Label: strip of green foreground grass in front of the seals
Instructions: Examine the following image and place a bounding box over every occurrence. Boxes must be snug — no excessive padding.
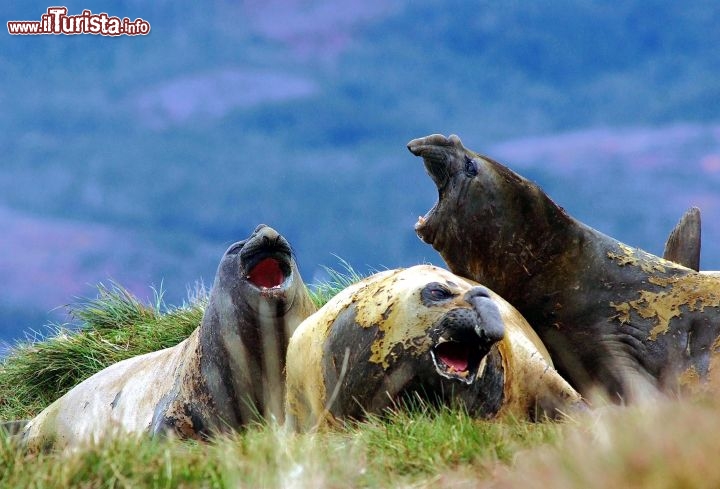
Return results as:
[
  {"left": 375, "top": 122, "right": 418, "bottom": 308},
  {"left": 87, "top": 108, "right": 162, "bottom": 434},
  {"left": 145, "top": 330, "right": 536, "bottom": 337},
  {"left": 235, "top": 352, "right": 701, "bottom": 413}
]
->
[{"left": 0, "top": 409, "right": 559, "bottom": 488}]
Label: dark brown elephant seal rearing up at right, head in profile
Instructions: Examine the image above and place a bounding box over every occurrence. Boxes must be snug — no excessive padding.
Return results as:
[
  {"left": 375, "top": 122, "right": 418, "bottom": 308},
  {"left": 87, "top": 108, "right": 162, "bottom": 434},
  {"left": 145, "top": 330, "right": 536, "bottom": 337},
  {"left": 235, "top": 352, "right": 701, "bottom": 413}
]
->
[{"left": 408, "top": 135, "right": 720, "bottom": 401}]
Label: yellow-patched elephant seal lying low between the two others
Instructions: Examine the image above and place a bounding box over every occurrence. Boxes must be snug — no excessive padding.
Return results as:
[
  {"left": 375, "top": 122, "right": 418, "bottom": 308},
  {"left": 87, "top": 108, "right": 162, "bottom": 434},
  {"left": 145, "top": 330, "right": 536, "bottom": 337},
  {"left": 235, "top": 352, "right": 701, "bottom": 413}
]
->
[{"left": 286, "top": 265, "right": 584, "bottom": 431}]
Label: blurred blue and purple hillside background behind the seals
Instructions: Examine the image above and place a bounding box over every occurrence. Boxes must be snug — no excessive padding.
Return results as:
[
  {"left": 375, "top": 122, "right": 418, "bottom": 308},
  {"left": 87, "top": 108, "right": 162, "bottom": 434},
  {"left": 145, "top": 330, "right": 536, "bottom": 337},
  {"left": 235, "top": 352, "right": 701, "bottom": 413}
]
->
[{"left": 0, "top": 0, "right": 720, "bottom": 339}]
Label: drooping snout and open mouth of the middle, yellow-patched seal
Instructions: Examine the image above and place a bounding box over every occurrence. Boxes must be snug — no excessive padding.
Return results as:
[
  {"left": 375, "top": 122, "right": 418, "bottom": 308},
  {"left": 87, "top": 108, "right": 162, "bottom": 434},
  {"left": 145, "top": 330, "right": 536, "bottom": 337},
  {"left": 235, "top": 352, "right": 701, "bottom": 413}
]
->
[{"left": 430, "top": 287, "right": 505, "bottom": 384}]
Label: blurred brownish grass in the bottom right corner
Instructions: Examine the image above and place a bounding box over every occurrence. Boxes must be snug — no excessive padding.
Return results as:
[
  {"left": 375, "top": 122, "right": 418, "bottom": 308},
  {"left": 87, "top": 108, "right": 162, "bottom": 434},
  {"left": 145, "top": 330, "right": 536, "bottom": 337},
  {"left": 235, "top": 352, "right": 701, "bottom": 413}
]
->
[{"left": 486, "top": 397, "right": 720, "bottom": 489}]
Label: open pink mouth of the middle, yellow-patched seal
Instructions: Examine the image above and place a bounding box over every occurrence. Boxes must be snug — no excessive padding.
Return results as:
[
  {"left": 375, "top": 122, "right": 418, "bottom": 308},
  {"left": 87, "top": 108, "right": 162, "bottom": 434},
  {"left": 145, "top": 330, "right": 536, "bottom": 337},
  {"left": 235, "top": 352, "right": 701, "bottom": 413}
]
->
[{"left": 430, "top": 331, "right": 489, "bottom": 384}]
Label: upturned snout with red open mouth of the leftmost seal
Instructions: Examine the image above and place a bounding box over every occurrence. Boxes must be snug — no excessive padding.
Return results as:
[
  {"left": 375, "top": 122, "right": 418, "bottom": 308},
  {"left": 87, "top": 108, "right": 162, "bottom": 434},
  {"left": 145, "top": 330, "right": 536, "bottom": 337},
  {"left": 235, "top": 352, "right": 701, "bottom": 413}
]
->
[{"left": 240, "top": 224, "right": 292, "bottom": 290}]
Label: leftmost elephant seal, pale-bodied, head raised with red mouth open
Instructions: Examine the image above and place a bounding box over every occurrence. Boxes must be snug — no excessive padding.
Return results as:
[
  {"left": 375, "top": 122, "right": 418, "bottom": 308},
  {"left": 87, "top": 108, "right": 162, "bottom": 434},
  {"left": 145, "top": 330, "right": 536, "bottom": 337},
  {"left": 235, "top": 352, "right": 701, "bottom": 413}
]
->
[{"left": 23, "top": 225, "right": 316, "bottom": 449}]
